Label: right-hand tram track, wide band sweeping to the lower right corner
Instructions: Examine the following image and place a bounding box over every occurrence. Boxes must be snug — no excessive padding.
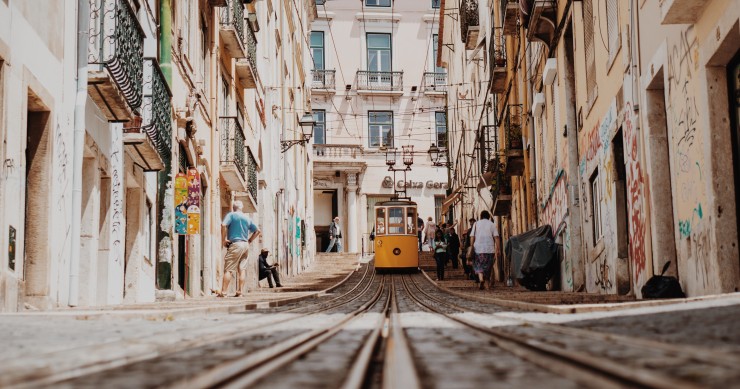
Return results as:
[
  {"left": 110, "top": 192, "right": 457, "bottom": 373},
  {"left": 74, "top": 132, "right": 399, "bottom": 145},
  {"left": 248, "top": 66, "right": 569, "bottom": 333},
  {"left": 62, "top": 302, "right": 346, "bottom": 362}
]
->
[{"left": 403, "top": 277, "right": 740, "bottom": 388}]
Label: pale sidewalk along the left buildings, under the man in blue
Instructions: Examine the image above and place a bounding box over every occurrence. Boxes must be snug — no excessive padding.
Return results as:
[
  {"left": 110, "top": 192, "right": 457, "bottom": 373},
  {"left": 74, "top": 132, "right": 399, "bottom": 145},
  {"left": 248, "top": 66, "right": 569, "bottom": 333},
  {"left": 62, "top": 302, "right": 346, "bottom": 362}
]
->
[{"left": 8, "top": 254, "right": 359, "bottom": 321}]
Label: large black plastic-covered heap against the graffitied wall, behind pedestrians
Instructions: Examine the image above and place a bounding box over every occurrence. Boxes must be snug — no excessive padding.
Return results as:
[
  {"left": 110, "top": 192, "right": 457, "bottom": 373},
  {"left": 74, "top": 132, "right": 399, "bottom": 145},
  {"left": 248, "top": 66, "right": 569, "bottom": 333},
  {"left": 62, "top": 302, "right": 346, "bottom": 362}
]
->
[{"left": 505, "top": 225, "right": 560, "bottom": 290}]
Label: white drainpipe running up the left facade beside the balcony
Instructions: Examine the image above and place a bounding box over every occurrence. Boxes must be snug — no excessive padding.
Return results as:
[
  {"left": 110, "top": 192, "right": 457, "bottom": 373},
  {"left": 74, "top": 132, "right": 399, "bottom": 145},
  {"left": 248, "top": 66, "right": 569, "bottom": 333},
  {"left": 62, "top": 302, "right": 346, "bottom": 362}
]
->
[{"left": 67, "top": 0, "right": 90, "bottom": 307}]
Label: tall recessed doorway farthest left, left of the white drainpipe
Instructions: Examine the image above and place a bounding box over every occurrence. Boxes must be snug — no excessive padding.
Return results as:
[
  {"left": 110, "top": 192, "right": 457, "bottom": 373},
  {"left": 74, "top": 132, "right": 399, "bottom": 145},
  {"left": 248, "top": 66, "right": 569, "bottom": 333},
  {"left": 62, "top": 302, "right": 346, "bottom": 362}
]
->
[{"left": 23, "top": 91, "right": 51, "bottom": 297}]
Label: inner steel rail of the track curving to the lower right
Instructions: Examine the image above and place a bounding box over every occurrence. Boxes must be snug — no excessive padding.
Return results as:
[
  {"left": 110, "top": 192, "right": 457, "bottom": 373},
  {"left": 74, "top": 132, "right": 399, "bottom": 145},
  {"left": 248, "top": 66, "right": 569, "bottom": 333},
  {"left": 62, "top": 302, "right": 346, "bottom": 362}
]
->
[{"left": 403, "top": 278, "right": 701, "bottom": 389}]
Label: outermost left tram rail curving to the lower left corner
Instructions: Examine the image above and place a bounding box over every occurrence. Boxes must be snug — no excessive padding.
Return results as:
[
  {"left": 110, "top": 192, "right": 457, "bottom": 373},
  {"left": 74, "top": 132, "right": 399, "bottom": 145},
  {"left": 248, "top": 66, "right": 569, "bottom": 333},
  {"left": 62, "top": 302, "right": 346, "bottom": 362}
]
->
[{"left": 19, "top": 264, "right": 375, "bottom": 387}]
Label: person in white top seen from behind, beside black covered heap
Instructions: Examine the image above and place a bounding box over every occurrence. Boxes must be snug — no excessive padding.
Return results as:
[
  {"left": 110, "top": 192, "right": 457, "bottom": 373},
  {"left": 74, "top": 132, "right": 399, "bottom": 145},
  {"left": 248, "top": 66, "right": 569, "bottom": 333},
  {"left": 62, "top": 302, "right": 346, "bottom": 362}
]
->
[{"left": 468, "top": 211, "right": 501, "bottom": 289}]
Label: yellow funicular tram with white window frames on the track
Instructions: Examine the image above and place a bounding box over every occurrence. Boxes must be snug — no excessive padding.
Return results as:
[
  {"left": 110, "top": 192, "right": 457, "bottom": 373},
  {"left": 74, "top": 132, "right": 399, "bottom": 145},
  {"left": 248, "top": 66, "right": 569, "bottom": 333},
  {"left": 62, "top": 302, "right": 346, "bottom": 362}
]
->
[{"left": 374, "top": 198, "right": 419, "bottom": 271}]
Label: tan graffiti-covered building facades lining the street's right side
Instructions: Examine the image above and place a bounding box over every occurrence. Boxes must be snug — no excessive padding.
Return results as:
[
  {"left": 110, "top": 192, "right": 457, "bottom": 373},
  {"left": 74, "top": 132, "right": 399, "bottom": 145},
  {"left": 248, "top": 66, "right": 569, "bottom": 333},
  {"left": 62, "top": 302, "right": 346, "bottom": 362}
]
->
[{"left": 440, "top": 0, "right": 740, "bottom": 297}]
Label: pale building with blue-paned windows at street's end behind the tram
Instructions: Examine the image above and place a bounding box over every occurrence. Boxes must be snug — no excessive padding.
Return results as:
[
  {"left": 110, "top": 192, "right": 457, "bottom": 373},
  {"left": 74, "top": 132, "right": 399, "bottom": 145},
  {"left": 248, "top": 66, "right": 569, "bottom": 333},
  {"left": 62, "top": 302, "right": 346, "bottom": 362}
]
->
[{"left": 306, "top": 0, "right": 448, "bottom": 252}]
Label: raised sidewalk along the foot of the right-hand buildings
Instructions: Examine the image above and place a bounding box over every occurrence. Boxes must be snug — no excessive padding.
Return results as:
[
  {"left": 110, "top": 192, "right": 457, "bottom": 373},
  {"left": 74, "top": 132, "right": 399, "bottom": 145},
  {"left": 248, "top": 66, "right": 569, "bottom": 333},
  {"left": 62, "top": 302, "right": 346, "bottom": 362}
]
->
[{"left": 419, "top": 253, "right": 740, "bottom": 314}]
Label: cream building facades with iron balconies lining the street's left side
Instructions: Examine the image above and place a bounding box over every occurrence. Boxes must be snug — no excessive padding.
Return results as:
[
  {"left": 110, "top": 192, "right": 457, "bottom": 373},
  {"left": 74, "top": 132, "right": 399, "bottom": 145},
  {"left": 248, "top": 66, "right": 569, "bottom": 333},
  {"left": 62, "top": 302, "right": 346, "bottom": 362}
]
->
[{"left": 0, "top": 0, "right": 315, "bottom": 311}]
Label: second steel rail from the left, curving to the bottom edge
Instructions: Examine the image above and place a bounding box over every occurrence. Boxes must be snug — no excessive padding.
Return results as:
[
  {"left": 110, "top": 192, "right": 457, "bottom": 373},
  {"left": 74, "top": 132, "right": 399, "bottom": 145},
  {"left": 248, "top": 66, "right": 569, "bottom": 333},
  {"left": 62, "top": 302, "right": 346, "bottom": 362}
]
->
[{"left": 185, "top": 278, "right": 385, "bottom": 388}]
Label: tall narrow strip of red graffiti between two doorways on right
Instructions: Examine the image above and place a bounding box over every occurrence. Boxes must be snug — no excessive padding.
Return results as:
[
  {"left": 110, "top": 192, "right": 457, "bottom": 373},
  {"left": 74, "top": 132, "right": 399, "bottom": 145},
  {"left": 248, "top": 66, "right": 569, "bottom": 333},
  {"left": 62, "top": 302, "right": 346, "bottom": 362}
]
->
[{"left": 622, "top": 102, "right": 647, "bottom": 285}]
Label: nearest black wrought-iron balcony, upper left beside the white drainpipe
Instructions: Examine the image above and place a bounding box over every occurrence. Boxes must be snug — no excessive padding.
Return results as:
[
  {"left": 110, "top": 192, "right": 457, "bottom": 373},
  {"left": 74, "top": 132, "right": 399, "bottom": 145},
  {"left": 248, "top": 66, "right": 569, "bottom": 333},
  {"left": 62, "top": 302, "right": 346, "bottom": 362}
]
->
[{"left": 87, "top": 0, "right": 144, "bottom": 122}]
